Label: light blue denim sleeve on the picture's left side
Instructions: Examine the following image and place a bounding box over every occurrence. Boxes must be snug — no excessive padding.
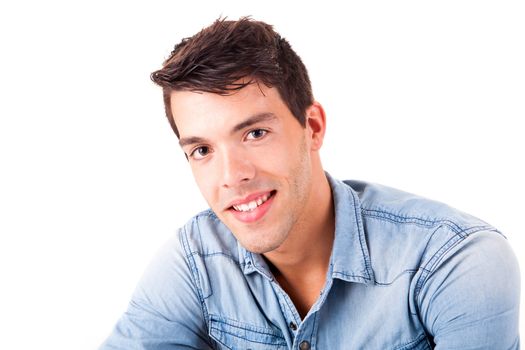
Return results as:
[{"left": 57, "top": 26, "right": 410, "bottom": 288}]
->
[{"left": 99, "top": 231, "right": 212, "bottom": 350}]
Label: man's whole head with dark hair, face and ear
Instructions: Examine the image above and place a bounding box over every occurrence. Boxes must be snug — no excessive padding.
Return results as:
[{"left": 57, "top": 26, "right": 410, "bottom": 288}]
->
[{"left": 149, "top": 19, "right": 329, "bottom": 253}]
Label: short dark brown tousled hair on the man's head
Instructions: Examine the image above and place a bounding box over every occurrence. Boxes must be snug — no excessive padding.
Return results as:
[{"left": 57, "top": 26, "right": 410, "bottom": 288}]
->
[{"left": 151, "top": 17, "right": 313, "bottom": 137}]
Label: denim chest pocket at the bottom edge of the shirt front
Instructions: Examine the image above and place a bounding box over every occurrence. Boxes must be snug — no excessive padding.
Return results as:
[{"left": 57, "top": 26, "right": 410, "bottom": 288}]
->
[{"left": 209, "top": 315, "right": 287, "bottom": 350}]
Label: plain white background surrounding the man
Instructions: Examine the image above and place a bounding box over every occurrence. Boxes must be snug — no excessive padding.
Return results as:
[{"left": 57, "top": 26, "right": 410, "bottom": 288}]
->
[{"left": 0, "top": 0, "right": 525, "bottom": 349}]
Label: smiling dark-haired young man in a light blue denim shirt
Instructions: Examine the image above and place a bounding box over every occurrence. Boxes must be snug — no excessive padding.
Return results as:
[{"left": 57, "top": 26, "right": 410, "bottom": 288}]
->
[{"left": 102, "top": 18, "right": 520, "bottom": 350}]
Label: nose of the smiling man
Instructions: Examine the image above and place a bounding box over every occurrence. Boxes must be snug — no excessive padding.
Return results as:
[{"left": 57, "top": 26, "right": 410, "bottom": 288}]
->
[{"left": 222, "top": 150, "right": 255, "bottom": 188}]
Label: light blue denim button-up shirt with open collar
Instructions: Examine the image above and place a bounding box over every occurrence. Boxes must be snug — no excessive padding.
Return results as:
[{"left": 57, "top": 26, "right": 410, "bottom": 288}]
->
[{"left": 101, "top": 175, "right": 520, "bottom": 350}]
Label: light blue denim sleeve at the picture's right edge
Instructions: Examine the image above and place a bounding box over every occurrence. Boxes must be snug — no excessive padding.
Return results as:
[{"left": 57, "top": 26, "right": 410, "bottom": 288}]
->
[{"left": 418, "top": 232, "right": 520, "bottom": 350}]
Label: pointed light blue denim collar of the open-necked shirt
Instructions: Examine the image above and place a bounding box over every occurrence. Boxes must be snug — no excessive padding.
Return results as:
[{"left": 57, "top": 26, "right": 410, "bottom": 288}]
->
[{"left": 238, "top": 173, "right": 374, "bottom": 283}]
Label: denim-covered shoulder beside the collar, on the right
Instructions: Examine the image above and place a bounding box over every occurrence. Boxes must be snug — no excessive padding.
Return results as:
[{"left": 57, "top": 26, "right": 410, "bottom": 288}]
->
[{"left": 344, "top": 181, "right": 505, "bottom": 284}]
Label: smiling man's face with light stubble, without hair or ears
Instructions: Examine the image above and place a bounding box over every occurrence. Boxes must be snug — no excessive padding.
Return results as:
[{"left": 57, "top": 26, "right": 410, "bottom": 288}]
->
[{"left": 171, "top": 84, "right": 312, "bottom": 253}]
